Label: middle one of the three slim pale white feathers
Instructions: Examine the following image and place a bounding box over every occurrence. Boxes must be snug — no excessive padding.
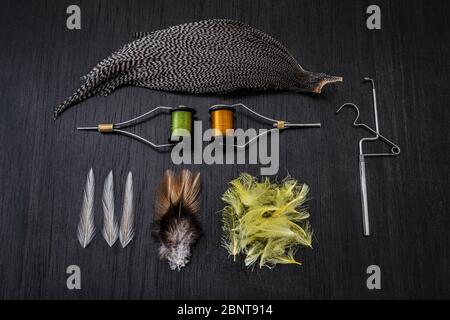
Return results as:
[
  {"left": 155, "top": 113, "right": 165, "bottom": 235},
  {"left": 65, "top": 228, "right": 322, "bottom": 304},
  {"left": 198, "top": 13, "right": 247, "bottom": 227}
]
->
[{"left": 102, "top": 171, "right": 119, "bottom": 247}]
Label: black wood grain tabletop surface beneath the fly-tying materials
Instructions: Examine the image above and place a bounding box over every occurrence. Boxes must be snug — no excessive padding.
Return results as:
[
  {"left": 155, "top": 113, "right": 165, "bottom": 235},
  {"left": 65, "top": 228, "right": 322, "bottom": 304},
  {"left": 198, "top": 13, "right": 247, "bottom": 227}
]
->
[{"left": 0, "top": 0, "right": 450, "bottom": 299}]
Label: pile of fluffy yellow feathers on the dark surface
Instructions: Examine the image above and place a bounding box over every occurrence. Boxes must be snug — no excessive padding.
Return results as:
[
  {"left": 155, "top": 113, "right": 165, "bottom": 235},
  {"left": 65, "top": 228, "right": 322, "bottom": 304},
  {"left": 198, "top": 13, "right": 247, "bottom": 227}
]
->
[{"left": 222, "top": 173, "right": 312, "bottom": 268}]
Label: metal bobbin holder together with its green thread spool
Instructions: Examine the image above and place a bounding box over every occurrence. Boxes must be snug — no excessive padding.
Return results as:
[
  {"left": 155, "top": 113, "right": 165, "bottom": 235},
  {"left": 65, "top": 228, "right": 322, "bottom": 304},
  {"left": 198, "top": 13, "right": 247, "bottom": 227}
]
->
[{"left": 77, "top": 105, "right": 195, "bottom": 149}]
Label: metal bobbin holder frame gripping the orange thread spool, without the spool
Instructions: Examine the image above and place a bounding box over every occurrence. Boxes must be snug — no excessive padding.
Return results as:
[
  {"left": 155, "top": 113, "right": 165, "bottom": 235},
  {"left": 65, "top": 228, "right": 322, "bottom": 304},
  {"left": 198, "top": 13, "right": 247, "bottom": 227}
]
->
[{"left": 209, "top": 103, "right": 322, "bottom": 148}]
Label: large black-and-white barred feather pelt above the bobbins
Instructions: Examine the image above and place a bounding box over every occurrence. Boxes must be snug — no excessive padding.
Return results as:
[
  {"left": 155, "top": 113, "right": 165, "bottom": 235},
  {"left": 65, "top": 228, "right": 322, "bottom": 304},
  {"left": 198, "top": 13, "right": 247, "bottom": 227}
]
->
[{"left": 53, "top": 19, "right": 342, "bottom": 119}]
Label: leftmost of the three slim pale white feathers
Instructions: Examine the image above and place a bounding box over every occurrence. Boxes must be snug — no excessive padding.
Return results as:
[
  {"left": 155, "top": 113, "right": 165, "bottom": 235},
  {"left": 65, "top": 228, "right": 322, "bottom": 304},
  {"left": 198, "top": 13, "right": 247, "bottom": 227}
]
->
[{"left": 77, "top": 168, "right": 95, "bottom": 248}]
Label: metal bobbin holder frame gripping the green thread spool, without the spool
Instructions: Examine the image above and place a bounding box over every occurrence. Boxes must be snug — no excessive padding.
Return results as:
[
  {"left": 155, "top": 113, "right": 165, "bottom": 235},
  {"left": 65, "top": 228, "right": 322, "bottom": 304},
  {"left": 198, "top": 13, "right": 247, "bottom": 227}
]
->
[{"left": 77, "top": 106, "right": 177, "bottom": 149}]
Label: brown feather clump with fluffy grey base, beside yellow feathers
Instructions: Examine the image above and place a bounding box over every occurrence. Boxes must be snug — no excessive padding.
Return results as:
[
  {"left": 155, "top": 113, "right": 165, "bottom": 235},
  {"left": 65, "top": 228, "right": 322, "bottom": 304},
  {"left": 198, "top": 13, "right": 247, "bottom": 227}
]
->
[{"left": 154, "top": 169, "right": 201, "bottom": 271}]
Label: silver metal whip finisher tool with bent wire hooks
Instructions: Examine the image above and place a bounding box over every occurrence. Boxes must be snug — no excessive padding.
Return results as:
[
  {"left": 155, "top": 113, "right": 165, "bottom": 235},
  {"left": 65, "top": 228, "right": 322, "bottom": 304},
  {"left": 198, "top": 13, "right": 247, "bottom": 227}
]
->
[{"left": 336, "top": 77, "right": 400, "bottom": 236}]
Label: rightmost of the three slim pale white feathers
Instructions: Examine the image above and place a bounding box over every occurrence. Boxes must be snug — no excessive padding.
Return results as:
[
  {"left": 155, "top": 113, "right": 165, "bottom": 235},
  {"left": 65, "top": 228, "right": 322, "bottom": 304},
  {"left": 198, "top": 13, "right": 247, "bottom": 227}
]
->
[{"left": 119, "top": 172, "right": 134, "bottom": 248}]
